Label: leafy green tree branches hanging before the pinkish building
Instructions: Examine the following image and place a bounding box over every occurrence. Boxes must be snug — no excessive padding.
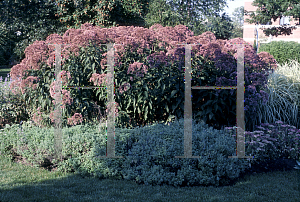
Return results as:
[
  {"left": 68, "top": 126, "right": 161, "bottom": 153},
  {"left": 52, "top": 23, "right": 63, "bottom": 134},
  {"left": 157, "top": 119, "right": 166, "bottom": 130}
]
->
[{"left": 245, "top": 0, "right": 300, "bottom": 37}]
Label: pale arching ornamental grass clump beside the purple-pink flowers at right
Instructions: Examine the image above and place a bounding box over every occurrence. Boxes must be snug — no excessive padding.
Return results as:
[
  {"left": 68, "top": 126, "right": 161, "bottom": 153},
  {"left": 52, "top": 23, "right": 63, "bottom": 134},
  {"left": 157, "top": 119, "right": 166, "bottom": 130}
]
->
[{"left": 258, "top": 60, "right": 300, "bottom": 129}]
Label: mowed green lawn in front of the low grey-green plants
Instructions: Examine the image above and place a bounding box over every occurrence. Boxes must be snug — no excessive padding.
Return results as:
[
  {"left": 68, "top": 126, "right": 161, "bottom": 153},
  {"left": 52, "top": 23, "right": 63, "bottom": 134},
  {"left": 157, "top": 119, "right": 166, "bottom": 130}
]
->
[{"left": 0, "top": 153, "right": 300, "bottom": 202}]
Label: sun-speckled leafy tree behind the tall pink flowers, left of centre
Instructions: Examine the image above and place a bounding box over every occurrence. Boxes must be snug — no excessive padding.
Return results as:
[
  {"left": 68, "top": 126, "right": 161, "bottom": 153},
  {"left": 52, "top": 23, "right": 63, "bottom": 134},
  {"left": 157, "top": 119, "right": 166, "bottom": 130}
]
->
[{"left": 48, "top": 0, "right": 154, "bottom": 29}]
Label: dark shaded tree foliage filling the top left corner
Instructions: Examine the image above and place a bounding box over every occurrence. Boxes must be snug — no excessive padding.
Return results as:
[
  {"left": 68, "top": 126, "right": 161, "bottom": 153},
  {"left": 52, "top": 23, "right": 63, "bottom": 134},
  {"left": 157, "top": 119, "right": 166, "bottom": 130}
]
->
[{"left": 0, "top": 0, "right": 71, "bottom": 64}]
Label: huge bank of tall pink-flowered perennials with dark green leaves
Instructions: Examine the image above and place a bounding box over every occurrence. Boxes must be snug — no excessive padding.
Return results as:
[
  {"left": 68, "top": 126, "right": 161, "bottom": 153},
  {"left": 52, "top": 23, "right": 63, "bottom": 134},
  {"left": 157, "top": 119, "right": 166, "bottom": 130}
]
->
[{"left": 4, "top": 23, "right": 276, "bottom": 133}]
